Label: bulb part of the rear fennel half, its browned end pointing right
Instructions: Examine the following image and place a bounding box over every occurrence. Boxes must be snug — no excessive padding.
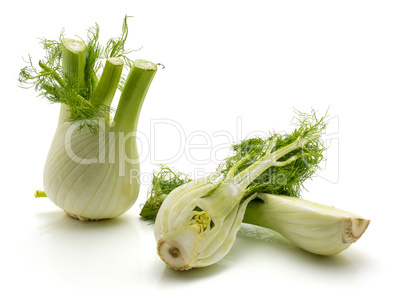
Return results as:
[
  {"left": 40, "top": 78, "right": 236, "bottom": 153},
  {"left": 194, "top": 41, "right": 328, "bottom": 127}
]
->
[{"left": 243, "top": 194, "right": 370, "bottom": 255}]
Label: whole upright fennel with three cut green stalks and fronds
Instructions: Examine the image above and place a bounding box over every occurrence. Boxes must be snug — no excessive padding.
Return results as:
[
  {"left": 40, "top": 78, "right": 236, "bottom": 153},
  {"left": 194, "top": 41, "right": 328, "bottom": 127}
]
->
[{"left": 19, "top": 17, "right": 157, "bottom": 220}]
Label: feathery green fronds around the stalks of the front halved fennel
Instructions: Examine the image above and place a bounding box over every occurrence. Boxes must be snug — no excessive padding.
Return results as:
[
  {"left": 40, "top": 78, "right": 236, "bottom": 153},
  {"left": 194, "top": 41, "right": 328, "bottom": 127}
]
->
[{"left": 226, "top": 111, "right": 327, "bottom": 198}]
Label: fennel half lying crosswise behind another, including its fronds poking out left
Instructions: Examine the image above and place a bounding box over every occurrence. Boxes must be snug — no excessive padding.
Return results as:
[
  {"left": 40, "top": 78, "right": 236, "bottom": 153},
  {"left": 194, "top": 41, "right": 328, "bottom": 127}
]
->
[{"left": 140, "top": 166, "right": 370, "bottom": 255}]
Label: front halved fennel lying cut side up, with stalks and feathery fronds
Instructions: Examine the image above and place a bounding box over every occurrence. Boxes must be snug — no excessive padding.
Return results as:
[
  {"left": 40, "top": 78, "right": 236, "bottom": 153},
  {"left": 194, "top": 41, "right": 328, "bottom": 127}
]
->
[{"left": 154, "top": 114, "right": 336, "bottom": 270}]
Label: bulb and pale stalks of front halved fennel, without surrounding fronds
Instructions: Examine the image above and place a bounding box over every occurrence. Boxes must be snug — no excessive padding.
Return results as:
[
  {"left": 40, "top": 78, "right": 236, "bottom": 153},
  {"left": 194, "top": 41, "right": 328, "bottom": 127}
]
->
[{"left": 154, "top": 122, "right": 322, "bottom": 270}]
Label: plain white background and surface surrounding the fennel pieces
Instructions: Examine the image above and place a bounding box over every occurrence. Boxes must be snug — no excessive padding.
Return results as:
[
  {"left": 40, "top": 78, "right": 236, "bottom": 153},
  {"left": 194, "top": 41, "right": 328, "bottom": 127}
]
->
[{"left": 0, "top": 0, "right": 402, "bottom": 299}]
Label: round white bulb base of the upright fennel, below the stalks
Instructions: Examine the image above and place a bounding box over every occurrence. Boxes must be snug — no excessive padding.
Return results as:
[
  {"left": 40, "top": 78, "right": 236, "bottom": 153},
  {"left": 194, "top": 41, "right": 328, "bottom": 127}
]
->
[{"left": 43, "top": 117, "right": 140, "bottom": 220}]
